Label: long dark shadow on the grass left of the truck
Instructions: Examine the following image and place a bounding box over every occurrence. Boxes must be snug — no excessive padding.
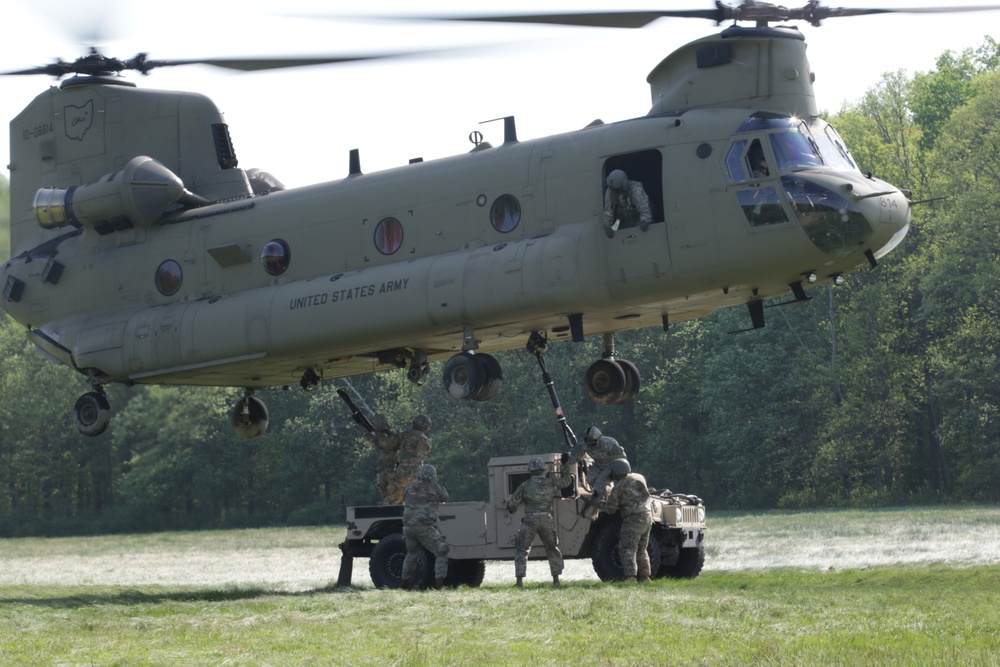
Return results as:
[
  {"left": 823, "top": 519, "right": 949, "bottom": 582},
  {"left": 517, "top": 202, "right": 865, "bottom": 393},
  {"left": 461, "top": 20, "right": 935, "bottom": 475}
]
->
[{"left": 0, "top": 585, "right": 359, "bottom": 609}]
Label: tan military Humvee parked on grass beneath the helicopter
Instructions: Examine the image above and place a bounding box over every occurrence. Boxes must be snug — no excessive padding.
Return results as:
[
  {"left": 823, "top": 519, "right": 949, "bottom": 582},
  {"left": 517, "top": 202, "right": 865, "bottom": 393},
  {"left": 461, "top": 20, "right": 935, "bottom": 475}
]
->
[{"left": 337, "top": 454, "right": 705, "bottom": 588}]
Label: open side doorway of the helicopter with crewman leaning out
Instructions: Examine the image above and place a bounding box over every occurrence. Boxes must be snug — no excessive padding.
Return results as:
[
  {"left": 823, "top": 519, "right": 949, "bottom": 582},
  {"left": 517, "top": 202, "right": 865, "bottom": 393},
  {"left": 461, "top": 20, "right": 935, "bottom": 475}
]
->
[{"left": 602, "top": 149, "right": 666, "bottom": 236}]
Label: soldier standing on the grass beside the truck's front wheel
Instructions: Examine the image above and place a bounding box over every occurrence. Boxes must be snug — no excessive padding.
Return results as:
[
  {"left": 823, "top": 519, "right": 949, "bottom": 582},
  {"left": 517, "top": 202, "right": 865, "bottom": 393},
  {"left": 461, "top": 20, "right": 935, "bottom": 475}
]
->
[{"left": 600, "top": 459, "right": 653, "bottom": 582}]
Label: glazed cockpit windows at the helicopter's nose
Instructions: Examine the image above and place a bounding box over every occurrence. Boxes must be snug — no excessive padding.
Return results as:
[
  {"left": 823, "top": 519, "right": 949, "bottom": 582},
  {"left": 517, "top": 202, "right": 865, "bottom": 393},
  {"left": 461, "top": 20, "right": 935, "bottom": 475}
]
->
[{"left": 726, "top": 112, "right": 873, "bottom": 255}]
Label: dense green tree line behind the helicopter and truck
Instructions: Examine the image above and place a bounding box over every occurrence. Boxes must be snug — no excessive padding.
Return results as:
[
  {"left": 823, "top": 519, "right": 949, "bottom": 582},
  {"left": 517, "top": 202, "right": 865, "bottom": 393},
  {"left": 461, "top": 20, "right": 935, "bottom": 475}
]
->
[{"left": 0, "top": 39, "right": 1000, "bottom": 536}]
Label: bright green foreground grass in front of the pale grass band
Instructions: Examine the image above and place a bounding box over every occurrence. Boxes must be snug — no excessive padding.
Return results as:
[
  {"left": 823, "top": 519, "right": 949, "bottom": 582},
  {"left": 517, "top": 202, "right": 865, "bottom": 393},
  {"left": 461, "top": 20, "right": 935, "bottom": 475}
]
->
[{"left": 0, "top": 566, "right": 1000, "bottom": 665}]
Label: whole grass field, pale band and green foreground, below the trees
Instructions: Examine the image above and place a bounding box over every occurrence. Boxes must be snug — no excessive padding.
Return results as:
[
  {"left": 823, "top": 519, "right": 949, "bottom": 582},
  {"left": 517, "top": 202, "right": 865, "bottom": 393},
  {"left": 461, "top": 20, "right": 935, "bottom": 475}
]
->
[{"left": 0, "top": 507, "right": 1000, "bottom": 667}]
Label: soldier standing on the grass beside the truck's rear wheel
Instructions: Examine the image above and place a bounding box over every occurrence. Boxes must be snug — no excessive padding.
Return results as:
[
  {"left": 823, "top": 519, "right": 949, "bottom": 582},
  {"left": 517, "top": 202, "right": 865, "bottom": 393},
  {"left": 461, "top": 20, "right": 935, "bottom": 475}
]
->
[{"left": 402, "top": 463, "right": 448, "bottom": 589}]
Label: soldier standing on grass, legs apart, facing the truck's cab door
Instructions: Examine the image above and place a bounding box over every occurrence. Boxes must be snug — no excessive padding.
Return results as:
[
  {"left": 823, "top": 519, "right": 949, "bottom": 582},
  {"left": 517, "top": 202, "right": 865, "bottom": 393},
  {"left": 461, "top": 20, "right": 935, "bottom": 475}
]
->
[{"left": 507, "top": 458, "right": 573, "bottom": 588}]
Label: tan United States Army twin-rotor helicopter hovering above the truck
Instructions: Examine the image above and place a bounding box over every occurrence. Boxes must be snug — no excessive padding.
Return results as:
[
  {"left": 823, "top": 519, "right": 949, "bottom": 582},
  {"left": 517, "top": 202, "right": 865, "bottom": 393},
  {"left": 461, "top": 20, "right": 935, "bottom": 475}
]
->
[{"left": 0, "top": 1, "right": 981, "bottom": 438}]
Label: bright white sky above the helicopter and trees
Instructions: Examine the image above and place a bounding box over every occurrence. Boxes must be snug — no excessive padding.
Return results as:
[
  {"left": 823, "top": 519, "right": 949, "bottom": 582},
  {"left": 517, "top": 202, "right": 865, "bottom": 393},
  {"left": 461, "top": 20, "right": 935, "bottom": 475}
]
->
[{"left": 0, "top": 0, "right": 1000, "bottom": 187}]
